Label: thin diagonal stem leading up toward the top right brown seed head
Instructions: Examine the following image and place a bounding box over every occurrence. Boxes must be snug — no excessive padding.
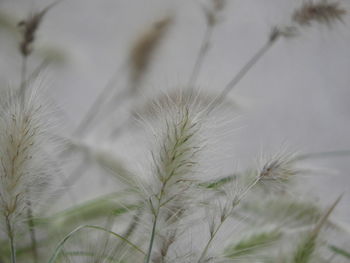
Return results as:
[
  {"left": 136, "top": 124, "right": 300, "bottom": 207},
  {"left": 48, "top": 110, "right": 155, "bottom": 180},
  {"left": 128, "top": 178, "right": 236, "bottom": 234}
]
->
[{"left": 208, "top": 36, "right": 279, "bottom": 114}]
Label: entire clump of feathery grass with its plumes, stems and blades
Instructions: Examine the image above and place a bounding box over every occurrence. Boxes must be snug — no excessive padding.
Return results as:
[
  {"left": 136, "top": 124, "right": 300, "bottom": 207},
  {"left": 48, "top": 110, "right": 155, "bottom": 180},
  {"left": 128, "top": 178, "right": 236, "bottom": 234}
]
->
[{"left": 0, "top": 0, "right": 348, "bottom": 263}]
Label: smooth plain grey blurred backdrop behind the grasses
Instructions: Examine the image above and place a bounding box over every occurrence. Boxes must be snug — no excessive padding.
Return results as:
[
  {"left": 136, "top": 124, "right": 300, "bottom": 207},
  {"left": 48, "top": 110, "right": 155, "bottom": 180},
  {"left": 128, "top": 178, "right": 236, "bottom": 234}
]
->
[{"left": 0, "top": 0, "right": 350, "bottom": 222}]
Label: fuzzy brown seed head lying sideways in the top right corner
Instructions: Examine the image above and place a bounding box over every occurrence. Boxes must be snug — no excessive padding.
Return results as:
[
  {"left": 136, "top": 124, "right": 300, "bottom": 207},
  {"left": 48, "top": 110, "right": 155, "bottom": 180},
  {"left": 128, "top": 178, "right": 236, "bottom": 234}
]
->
[{"left": 293, "top": 0, "right": 346, "bottom": 25}]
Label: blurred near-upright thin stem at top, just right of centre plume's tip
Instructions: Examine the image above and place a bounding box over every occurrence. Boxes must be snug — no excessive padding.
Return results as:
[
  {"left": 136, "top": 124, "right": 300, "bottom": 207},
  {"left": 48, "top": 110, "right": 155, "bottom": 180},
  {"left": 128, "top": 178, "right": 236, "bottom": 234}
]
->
[{"left": 188, "top": 24, "right": 214, "bottom": 89}]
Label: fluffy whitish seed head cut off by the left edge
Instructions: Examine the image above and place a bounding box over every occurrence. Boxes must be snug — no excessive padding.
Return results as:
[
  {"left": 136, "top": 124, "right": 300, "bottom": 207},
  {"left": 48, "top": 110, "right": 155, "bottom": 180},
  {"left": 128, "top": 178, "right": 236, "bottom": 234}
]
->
[{"left": 0, "top": 86, "right": 56, "bottom": 227}]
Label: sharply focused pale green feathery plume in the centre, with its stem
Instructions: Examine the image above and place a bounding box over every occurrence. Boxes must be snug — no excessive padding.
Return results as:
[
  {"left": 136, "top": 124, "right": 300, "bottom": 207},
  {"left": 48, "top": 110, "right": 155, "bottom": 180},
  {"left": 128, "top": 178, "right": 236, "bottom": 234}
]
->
[{"left": 141, "top": 92, "right": 201, "bottom": 263}]
